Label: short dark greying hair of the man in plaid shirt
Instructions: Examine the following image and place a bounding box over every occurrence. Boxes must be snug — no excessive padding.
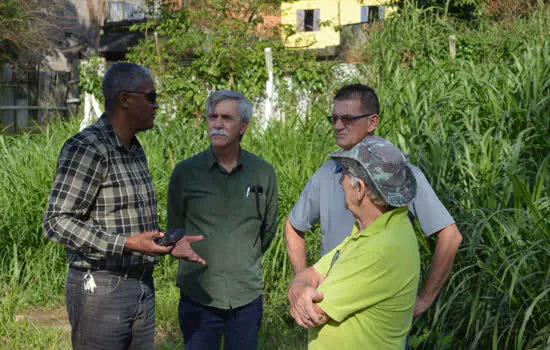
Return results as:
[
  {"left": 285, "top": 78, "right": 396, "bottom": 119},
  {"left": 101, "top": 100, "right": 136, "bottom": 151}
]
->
[{"left": 101, "top": 62, "right": 152, "bottom": 110}]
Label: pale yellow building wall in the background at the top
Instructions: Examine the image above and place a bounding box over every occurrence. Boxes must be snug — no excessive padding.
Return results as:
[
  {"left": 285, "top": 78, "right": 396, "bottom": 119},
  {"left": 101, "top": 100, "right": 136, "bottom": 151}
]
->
[{"left": 281, "top": 0, "right": 389, "bottom": 49}]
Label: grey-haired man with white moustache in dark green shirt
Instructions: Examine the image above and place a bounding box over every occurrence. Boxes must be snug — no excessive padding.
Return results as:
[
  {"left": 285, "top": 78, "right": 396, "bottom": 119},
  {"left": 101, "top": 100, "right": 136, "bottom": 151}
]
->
[{"left": 168, "top": 90, "right": 277, "bottom": 350}]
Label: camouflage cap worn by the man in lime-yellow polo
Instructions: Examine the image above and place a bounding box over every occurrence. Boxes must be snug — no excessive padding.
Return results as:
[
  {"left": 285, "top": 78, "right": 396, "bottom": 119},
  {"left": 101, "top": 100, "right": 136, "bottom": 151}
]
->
[{"left": 330, "top": 136, "right": 416, "bottom": 207}]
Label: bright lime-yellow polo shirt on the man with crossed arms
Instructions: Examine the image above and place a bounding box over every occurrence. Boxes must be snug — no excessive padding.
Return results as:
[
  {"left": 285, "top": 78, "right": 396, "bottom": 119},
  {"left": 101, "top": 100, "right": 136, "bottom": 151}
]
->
[{"left": 308, "top": 207, "right": 420, "bottom": 350}]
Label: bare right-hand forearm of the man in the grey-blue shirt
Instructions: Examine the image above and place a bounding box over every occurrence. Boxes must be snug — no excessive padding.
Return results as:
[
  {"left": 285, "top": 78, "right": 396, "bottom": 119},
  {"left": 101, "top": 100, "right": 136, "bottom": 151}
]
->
[{"left": 418, "top": 224, "right": 462, "bottom": 305}]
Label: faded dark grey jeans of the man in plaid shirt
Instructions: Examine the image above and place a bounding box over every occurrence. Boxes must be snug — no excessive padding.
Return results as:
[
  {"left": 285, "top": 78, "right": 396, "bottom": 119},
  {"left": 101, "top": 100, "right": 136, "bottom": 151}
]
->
[{"left": 65, "top": 266, "right": 155, "bottom": 350}]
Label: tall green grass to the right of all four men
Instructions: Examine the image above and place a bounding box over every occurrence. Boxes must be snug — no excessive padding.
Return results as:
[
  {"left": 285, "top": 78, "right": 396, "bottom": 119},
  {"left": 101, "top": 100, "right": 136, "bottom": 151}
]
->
[{"left": 366, "top": 8, "right": 550, "bottom": 349}]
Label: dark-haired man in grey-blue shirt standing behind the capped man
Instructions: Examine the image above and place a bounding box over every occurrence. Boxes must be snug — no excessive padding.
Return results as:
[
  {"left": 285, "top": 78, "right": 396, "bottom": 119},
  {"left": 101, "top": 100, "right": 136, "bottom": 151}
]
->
[{"left": 285, "top": 84, "right": 462, "bottom": 316}]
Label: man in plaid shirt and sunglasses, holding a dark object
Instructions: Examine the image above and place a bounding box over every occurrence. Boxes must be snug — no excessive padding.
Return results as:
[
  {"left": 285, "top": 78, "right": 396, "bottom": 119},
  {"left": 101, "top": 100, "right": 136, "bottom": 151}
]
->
[{"left": 43, "top": 63, "right": 187, "bottom": 349}]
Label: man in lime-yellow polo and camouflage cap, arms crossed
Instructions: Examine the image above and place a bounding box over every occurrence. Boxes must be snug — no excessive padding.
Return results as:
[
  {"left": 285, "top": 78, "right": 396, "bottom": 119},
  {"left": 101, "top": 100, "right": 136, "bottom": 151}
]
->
[{"left": 288, "top": 136, "right": 420, "bottom": 350}]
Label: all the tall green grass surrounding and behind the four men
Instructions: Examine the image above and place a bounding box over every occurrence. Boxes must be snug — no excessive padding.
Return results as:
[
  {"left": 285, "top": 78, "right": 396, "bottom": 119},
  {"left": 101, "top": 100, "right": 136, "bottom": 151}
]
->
[{"left": 0, "top": 4, "right": 550, "bottom": 349}]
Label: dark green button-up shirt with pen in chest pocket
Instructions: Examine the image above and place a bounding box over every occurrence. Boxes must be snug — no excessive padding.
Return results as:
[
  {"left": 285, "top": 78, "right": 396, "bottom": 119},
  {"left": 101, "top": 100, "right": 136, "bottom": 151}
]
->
[{"left": 168, "top": 148, "right": 277, "bottom": 309}]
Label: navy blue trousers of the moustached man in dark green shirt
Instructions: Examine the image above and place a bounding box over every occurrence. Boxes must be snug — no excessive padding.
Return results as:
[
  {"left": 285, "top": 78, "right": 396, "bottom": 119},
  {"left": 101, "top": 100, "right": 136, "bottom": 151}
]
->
[{"left": 179, "top": 295, "right": 262, "bottom": 350}]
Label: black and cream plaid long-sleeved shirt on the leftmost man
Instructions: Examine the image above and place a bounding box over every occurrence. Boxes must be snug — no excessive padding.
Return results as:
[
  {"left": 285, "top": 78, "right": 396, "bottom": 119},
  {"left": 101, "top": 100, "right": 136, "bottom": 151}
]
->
[{"left": 43, "top": 115, "right": 158, "bottom": 269}]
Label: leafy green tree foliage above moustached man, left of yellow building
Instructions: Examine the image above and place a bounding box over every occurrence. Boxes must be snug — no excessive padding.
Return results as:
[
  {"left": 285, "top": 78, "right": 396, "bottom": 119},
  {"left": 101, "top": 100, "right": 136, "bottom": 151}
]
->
[{"left": 128, "top": 0, "right": 332, "bottom": 118}]
